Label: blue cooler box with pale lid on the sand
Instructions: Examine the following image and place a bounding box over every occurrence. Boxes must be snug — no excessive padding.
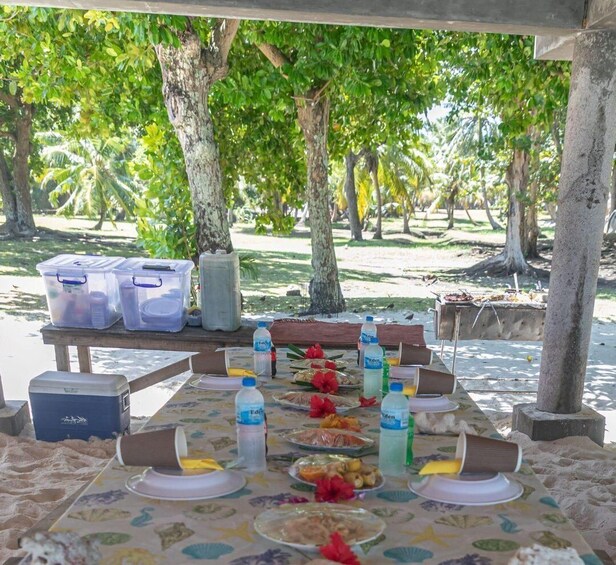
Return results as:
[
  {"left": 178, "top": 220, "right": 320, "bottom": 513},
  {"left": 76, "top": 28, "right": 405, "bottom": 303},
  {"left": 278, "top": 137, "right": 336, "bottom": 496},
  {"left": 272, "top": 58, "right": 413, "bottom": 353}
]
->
[{"left": 28, "top": 371, "right": 130, "bottom": 441}]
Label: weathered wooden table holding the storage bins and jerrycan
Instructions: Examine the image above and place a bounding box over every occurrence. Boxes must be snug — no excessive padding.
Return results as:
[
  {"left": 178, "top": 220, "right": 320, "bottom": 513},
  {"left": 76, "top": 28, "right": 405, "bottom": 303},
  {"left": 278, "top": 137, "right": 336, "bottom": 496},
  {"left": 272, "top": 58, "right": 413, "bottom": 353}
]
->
[{"left": 41, "top": 320, "right": 255, "bottom": 392}]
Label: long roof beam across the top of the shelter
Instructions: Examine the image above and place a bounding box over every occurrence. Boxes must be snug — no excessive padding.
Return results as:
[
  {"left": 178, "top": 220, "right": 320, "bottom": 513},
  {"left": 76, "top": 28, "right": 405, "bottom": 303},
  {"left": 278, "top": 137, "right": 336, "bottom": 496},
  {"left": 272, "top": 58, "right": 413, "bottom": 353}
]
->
[{"left": 2, "top": 0, "right": 584, "bottom": 35}]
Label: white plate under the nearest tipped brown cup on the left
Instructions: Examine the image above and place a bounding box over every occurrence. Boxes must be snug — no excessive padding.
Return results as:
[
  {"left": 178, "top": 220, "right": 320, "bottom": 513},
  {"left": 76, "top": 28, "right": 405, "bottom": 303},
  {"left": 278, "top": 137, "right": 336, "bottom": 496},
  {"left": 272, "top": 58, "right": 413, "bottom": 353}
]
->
[{"left": 126, "top": 467, "right": 246, "bottom": 500}]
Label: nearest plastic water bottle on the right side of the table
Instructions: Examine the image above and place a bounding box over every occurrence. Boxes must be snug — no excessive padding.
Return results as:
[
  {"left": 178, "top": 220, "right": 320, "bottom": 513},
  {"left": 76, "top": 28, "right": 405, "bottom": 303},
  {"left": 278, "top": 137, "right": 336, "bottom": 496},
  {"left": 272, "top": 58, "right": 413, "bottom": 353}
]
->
[{"left": 379, "top": 383, "right": 409, "bottom": 477}]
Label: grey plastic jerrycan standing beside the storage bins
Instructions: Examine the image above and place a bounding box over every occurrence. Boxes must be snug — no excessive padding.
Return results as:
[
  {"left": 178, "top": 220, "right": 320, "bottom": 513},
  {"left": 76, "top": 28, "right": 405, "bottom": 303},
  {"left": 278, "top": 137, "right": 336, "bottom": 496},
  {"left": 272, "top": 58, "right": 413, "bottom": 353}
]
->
[{"left": 199, "top": 251, "right": 242, "bottom": 332}]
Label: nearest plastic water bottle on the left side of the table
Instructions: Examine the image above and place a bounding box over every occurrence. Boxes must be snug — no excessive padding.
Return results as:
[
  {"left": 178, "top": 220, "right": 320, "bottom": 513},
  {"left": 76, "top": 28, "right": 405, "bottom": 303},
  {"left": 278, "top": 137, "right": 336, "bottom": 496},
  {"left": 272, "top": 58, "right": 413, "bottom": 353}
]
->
[{"left": 235, "top": 377, "right": 266, "bottom": 472}]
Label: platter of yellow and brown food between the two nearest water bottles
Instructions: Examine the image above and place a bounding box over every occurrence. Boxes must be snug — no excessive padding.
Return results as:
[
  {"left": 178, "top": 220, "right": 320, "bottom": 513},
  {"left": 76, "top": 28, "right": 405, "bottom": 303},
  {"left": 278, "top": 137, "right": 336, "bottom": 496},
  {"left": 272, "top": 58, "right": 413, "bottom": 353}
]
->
[{"left": 289, "top": 453, "right": 385, "bottom": 493}]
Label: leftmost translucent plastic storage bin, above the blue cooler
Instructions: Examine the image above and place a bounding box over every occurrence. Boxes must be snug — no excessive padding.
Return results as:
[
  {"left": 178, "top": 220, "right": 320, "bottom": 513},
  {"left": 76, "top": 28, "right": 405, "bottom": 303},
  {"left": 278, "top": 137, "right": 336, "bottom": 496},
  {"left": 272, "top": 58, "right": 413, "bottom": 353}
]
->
[{"left": 36, "top": 255, "right": 124, "bottom": 329}]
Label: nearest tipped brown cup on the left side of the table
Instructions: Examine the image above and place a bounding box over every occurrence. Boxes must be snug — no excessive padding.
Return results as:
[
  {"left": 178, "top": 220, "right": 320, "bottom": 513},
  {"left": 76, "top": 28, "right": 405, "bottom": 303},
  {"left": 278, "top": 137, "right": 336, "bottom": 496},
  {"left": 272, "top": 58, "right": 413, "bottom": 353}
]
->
[{"left": 116, "top": 426, "right": 188, "bottom": 469}]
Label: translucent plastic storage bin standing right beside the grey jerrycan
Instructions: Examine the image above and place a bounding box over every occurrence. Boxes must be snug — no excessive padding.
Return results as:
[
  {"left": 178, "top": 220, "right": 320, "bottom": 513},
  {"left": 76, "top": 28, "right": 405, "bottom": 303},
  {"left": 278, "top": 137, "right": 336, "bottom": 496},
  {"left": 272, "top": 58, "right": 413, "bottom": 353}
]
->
[{"left": 113, "top": 258, "right": 194, "bottom": 332}]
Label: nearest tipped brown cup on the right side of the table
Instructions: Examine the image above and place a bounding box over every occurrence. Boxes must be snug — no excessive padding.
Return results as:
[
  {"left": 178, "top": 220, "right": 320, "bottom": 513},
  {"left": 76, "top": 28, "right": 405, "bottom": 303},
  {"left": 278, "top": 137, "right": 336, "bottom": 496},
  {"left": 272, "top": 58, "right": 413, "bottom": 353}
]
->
[{"left": 456, "top": 432, "right": 522, "bottom": 473}]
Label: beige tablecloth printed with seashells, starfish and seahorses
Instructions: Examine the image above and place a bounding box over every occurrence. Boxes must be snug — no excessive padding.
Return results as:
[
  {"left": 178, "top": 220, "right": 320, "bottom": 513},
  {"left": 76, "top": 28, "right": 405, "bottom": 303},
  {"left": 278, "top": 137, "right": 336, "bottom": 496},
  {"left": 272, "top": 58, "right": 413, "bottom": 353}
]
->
[{"left": 53, "top": 350, "right": 600, "bottom": 565}]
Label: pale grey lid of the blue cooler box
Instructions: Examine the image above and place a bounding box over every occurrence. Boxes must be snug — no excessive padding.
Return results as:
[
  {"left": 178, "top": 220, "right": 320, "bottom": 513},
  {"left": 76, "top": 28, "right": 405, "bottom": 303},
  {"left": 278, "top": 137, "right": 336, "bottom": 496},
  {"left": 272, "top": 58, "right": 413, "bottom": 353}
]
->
[{"left": 28, "top": 371, "right": 129, "bottom": 396}]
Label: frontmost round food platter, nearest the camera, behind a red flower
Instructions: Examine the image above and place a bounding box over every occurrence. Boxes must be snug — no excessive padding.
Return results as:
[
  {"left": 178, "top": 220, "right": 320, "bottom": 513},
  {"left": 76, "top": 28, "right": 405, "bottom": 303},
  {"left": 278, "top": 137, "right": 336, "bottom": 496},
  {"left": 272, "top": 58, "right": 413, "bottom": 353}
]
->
[{"left": 254, "top": 502, "right": 385, "bottom": 551}]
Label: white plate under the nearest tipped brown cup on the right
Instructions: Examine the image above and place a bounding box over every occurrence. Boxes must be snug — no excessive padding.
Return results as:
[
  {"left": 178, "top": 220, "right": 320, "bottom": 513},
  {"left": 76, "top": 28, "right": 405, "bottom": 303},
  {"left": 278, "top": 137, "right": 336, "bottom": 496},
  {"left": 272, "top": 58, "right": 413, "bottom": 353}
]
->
[{"left": 409, "top": 473, "right": 524, "bottom": 506}]
